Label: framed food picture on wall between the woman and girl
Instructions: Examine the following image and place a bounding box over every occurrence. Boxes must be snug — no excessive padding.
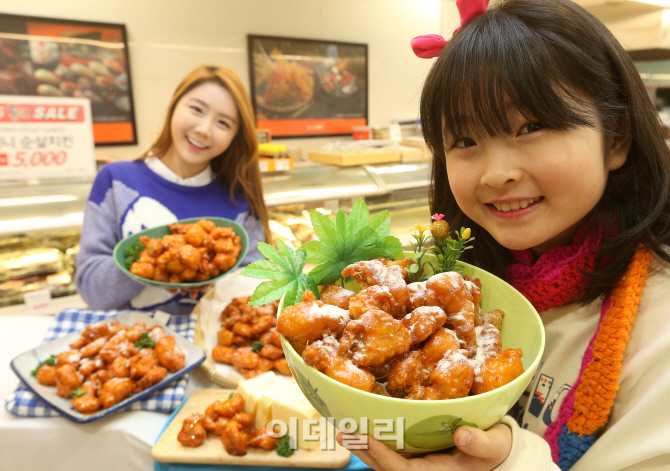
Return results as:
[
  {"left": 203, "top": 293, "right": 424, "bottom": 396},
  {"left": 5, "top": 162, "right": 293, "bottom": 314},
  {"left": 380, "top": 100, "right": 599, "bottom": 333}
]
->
[{"left": 247, "top": 35, "right": 368, "bottom": 138}]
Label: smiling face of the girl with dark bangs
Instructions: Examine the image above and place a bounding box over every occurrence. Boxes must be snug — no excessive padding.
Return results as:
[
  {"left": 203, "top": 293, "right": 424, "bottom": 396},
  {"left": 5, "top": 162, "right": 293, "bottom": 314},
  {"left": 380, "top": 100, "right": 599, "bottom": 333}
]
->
[{"left": 446, "top": 111, "right": 628, "bottom": 256}]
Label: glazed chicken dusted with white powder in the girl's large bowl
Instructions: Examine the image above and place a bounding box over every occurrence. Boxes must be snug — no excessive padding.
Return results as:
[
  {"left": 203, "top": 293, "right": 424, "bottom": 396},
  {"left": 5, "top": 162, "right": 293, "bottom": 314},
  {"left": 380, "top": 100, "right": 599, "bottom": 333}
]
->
[{"left": 277, "top": 258, "right": 524, "bottom": 400}]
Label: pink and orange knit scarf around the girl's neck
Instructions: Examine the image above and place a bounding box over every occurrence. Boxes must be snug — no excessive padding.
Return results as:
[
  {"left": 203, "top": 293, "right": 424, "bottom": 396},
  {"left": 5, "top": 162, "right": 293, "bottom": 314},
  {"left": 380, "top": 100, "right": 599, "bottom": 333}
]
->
[{"left": 507, "top": 226, "right": 651, "bottom": 471}]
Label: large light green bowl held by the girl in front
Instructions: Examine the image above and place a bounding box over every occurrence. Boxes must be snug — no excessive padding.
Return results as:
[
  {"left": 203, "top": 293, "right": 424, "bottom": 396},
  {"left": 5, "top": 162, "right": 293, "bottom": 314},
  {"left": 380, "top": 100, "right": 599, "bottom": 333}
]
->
[{"left": 278, "top": 252, "right": 544, "bottom": 453}]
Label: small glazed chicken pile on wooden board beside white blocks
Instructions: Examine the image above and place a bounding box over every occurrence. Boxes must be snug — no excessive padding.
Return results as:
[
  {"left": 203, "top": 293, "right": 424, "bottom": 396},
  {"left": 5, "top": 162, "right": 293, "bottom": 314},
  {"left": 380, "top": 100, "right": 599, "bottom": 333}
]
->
[{"left": 177, "top": 394, "right": 279, "bottom": 456}]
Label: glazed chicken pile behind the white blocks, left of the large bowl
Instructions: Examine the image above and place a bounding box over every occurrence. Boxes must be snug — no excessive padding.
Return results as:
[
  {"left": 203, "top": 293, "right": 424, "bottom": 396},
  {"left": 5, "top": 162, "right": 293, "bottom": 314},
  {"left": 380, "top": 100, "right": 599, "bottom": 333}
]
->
[{"left": 212, "top": 296, "right": 291, "bottom": 379}]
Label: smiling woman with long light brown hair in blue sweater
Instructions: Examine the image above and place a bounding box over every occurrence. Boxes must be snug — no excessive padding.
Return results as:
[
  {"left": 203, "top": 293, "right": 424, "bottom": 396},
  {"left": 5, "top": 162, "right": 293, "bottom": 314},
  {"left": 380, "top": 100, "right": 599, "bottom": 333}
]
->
[{"left": 75, "top": 66, "right": 270, "bottom": 314}]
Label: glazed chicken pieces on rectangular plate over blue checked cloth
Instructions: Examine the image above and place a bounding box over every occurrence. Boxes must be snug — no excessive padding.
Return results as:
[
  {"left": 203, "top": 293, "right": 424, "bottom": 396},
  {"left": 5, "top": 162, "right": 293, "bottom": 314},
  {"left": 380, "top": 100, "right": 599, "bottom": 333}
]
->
[{"left": 37, "top": 322, "right": 186, "bottom": 413}]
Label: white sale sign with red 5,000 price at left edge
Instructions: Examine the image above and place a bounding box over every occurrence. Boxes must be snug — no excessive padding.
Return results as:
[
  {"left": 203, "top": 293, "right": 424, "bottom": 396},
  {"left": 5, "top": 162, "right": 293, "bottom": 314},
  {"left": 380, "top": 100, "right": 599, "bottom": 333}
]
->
[{"left": 0, "top": 95, "right": 95, "bottom": 180}]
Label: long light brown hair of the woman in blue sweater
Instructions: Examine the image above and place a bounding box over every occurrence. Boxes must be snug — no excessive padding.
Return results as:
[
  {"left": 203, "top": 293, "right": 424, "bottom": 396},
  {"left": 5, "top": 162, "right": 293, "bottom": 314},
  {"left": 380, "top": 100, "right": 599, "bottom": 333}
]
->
[{"left": 140, "top": 65, "right": 271, "bottom": 242}]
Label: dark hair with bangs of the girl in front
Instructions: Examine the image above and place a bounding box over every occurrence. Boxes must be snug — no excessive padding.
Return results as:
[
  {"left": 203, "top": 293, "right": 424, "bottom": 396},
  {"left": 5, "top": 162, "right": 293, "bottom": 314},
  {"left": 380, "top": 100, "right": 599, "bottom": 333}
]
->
[{"left": 421, "top": 0, "right": 670, "bottom": 302}]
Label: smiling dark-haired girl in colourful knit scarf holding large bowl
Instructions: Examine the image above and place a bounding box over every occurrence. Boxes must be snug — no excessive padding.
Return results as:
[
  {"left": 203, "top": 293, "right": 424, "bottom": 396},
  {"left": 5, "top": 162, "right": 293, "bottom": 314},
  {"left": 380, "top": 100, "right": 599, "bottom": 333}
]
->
[{"left": 340, "top": 0, "right": 670, "bottom": 471}]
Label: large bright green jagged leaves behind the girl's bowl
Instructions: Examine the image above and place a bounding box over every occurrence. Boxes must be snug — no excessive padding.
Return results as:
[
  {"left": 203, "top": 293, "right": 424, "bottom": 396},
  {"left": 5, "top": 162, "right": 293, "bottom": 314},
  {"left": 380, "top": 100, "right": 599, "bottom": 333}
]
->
[{"left": 242, "top": 199, "right": 402, "bottom": 306}]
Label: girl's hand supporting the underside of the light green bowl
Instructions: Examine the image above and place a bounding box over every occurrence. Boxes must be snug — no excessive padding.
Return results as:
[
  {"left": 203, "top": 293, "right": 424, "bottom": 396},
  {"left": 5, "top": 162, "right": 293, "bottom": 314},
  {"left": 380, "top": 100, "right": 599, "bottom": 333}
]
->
[{"left": 337, "top": 424, "right": 512, "bottom": 471}]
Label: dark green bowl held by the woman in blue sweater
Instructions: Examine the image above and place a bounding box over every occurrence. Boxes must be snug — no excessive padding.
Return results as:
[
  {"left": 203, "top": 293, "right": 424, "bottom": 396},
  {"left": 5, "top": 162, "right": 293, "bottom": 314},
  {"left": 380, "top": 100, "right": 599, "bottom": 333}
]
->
[{"left": 114, "top": 217, "right": 249, "bottom": 289}]
